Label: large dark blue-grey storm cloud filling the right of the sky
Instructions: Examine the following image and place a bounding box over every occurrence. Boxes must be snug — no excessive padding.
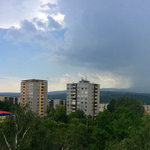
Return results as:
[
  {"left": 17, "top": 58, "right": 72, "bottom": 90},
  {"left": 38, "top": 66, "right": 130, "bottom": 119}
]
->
[{"left": 56, "top": 0, "right": 150, "bottom": 92}]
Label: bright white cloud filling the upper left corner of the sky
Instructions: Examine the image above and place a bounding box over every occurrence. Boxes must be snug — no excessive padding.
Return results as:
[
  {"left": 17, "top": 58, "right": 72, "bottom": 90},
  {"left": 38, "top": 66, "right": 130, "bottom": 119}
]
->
[{"left": 0, "top": 0, "right": 57, "bottom": 28}]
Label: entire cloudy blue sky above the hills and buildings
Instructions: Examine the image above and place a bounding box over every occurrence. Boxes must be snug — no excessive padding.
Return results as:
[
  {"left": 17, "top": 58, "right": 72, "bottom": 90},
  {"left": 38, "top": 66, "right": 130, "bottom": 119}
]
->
[{"left": 0, "top": 0, "right": 150, "bottom": 93}]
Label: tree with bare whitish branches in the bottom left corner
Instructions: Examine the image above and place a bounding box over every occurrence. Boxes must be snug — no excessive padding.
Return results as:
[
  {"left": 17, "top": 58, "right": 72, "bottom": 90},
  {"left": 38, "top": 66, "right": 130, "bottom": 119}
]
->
[{"left": 0, "top": 107, "right": 53, "bottom": 150}]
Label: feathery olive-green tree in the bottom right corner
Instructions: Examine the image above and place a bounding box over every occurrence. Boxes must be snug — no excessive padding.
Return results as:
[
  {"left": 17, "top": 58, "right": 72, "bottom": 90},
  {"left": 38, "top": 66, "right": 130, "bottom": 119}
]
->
[{"left": 106, "top": 116, "right": 150, "bottom": 150}]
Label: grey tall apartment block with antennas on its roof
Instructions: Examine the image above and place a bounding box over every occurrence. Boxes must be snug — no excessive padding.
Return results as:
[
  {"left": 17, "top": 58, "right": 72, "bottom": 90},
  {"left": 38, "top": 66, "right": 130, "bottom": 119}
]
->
[{"left": 66, "top": 79, "right": 100, "bottom": 118}]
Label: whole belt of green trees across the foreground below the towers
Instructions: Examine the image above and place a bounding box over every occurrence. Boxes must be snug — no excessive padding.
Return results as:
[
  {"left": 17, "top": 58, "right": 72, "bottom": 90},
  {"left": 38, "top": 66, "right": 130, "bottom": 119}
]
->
[{"left": 0, "top": 98, "right": 150, "bottom": 150}]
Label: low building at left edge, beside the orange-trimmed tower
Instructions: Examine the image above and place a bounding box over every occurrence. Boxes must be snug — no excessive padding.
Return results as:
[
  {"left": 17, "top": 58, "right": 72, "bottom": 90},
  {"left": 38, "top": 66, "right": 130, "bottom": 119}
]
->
[{"left": 0, "top": 96, "right": 20, "bottom": 105}]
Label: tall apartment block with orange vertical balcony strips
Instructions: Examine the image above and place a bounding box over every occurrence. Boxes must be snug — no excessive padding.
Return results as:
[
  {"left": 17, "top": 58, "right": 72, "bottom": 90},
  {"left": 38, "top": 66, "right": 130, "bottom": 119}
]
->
[{"left": 21, "top": 79, "right": 48, "bottom": 117}]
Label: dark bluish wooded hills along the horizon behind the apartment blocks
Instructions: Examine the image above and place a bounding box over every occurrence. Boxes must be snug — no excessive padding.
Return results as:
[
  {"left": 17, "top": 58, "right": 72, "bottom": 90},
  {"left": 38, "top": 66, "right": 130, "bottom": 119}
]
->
[{"left": 0, "top": 88, "right": 150, "bottom": 105}]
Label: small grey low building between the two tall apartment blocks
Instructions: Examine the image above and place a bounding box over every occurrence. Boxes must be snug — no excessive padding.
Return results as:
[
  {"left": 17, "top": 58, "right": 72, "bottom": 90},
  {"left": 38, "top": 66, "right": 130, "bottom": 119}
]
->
[{"left": 48, "top": 99, "right": 66, "bottom": 108}]
